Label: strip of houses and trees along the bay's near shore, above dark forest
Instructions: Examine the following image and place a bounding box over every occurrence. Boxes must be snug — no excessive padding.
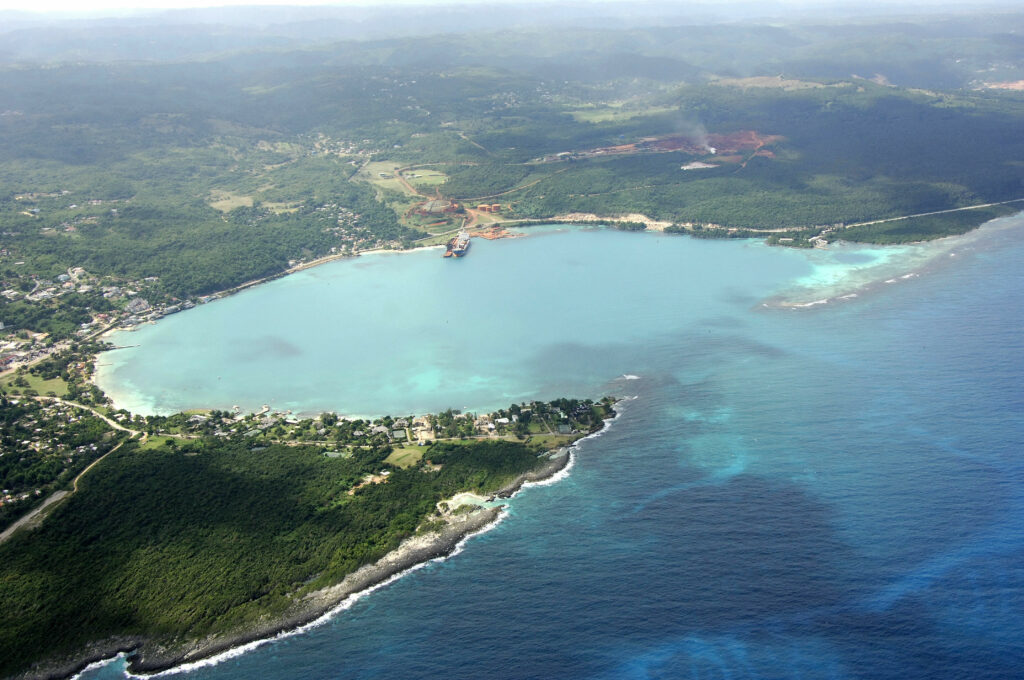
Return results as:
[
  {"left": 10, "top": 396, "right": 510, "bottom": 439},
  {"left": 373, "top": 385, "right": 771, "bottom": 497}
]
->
[{"left": 0, "top": 356, "right": 614, "bottom": 541}]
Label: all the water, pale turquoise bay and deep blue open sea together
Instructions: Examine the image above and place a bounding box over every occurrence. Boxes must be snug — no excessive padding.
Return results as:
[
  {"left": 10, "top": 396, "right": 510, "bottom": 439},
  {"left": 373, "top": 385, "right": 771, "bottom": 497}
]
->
[{"left": 85, "top": 216, "right": 1024, "bottom": 679}]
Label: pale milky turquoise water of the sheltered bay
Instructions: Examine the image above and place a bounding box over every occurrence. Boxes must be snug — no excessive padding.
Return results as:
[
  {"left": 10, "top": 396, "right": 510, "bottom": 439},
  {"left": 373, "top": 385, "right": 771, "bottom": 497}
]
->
[{"left": 98, "top": 229, "right": 946, "bottom": 415}]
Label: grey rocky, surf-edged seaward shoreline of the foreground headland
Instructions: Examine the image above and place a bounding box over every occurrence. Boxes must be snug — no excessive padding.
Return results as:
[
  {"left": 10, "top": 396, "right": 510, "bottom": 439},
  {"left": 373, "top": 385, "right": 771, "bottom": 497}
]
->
[{"left": 32, "top": 446, "right": 585, "bottom": 680}]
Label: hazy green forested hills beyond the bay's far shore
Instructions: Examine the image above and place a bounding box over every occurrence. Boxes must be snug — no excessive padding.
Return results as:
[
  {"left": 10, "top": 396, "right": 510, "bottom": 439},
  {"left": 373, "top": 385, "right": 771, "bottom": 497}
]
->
[{"left": 6, "top": 9, "right": 1024, "bottom": 330}]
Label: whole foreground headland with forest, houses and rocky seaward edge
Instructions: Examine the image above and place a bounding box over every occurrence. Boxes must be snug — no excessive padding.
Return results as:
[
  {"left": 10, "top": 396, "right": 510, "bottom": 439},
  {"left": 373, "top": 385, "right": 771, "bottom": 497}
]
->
[{"left": 0, "top": 396, "right": 614, "bottom": 678}]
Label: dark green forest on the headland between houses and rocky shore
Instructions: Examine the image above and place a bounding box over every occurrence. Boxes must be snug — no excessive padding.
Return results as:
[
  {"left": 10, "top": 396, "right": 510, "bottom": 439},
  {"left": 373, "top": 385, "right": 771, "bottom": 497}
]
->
[{"left": 0, "top": 438, "right": 577, "bottom": 676}]
